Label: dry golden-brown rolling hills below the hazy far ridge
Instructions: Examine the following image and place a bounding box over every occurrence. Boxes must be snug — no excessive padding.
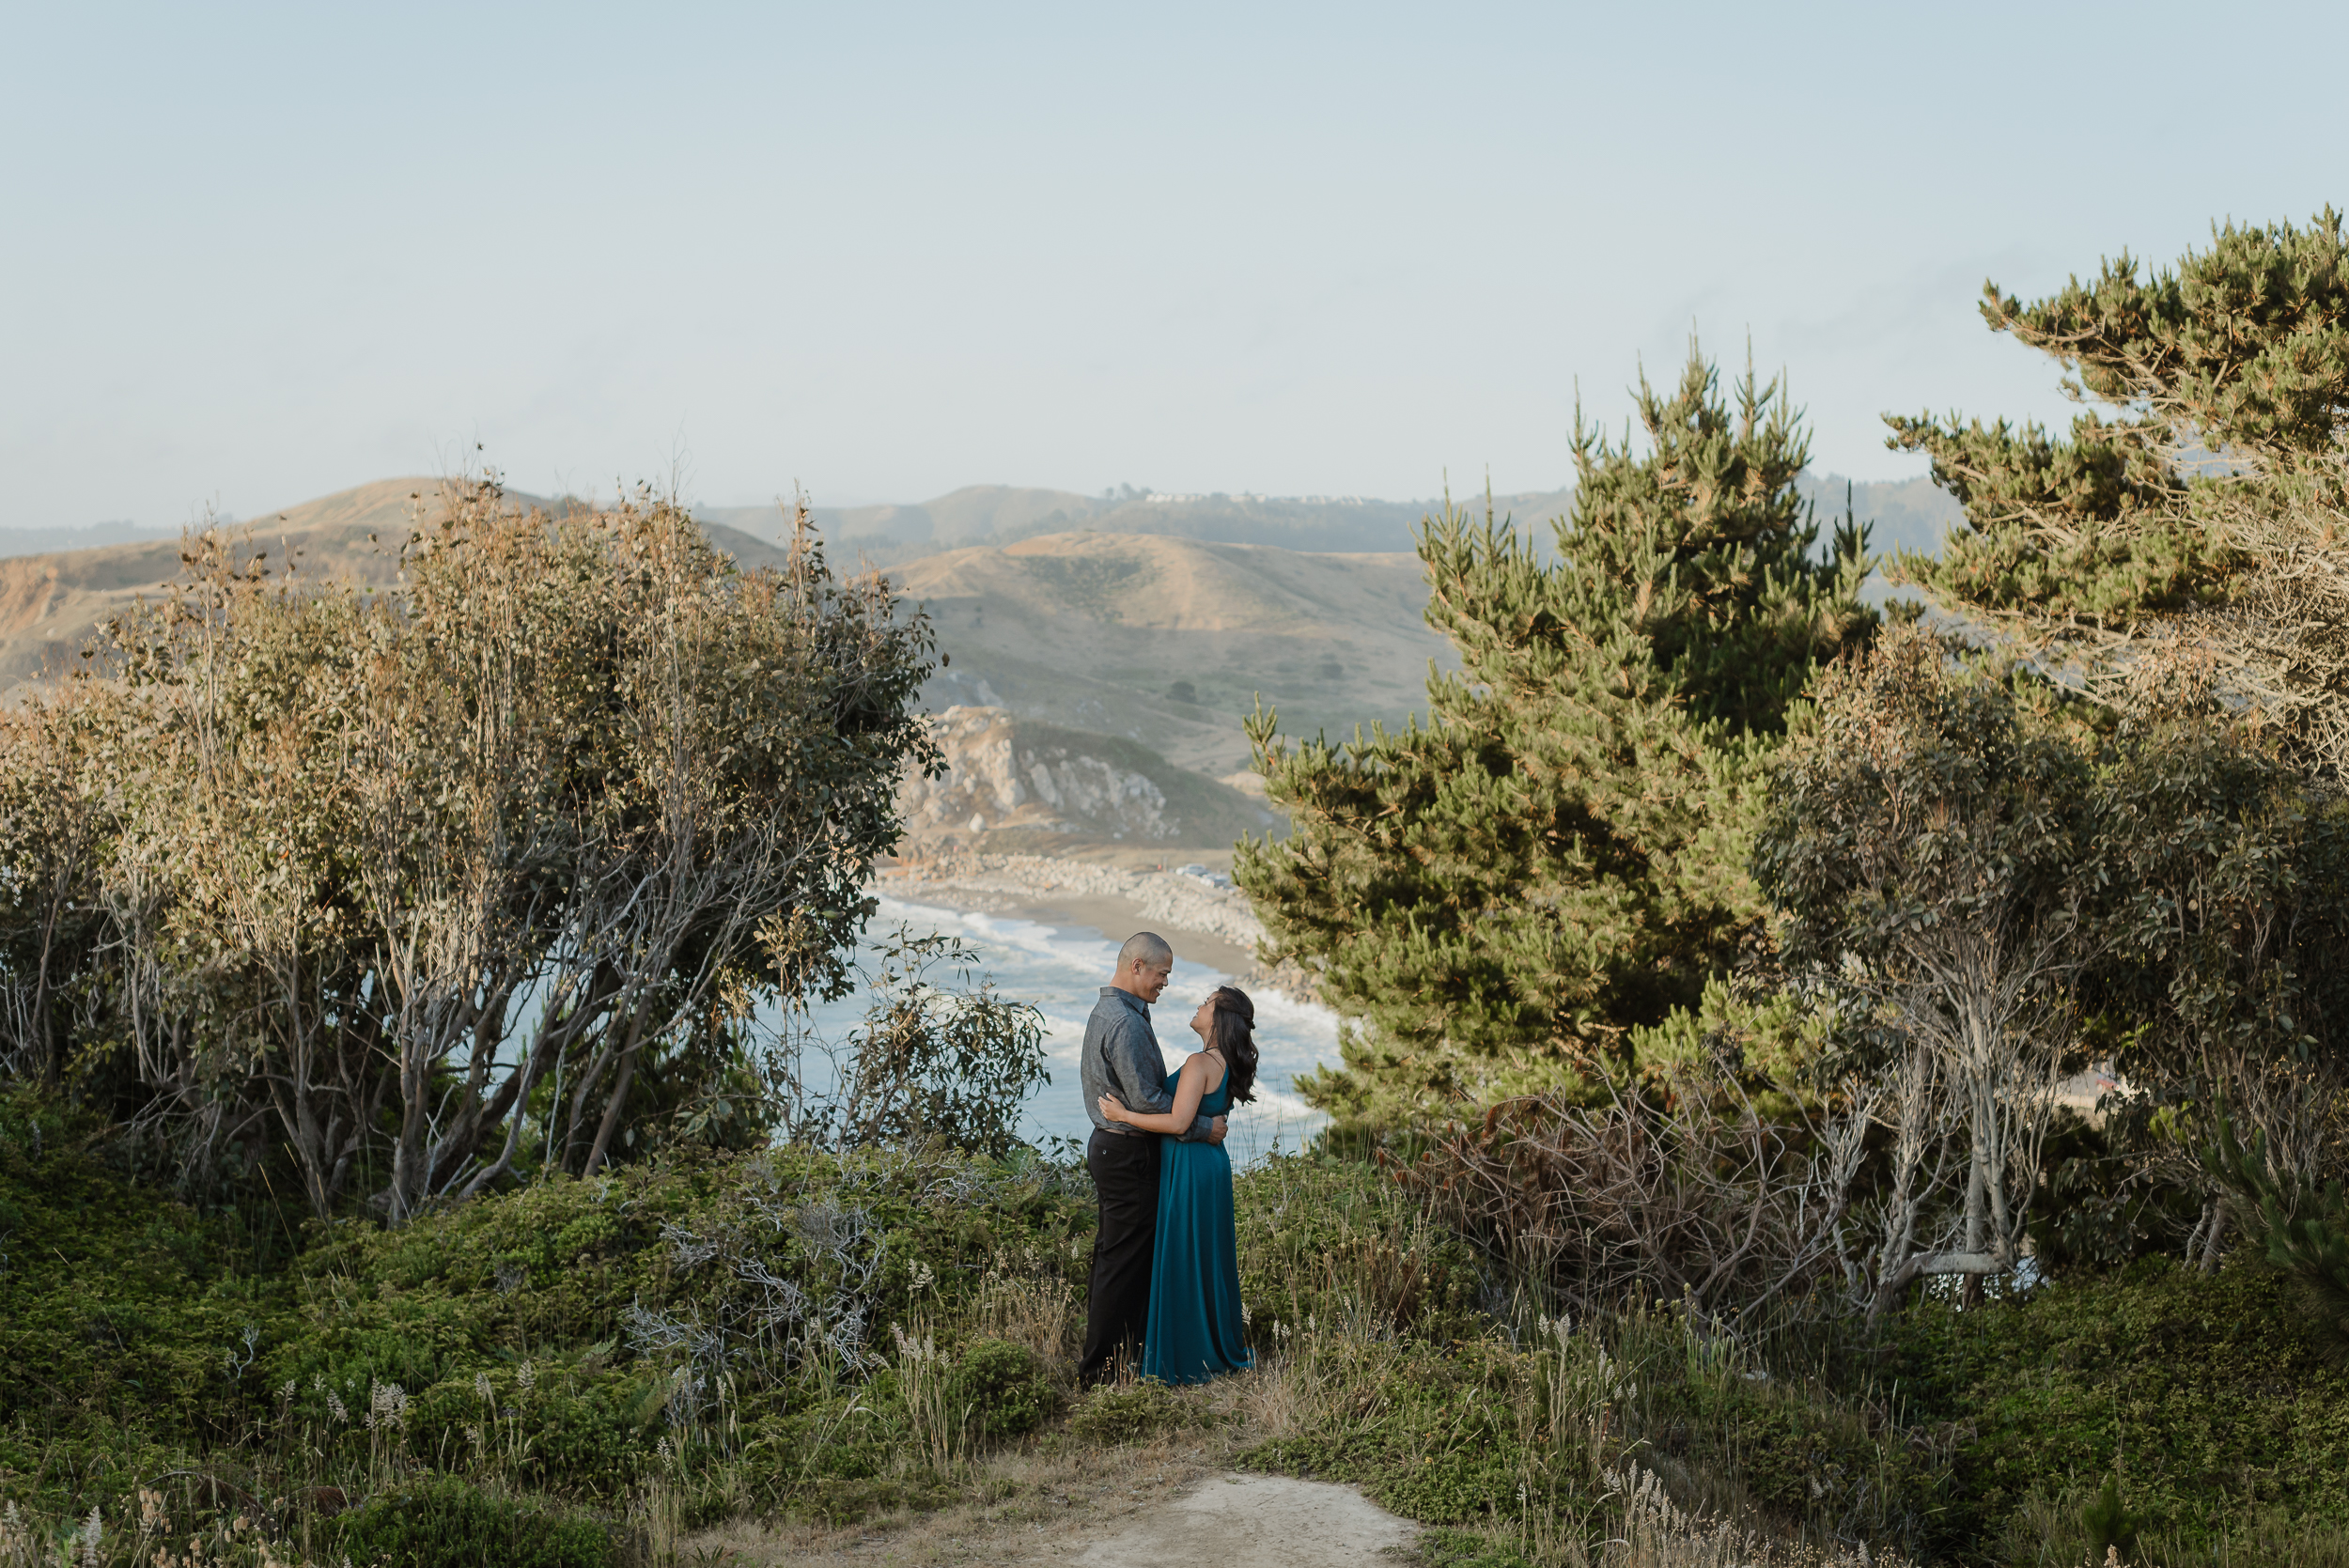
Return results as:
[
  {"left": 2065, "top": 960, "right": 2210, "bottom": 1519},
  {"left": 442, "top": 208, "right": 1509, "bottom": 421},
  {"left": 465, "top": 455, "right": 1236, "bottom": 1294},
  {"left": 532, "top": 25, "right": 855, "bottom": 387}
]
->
[{"left": 0, "top": 479, "right": 1450, "bottom": 780}]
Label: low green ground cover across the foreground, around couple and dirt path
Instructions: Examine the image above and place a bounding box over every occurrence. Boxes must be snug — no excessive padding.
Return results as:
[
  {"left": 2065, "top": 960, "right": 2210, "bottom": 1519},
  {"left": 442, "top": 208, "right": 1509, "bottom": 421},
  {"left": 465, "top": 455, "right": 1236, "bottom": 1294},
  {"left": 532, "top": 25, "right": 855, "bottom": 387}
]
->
[{"left": 0, "top": 1098, "right": 2349, "bottom": 1568}]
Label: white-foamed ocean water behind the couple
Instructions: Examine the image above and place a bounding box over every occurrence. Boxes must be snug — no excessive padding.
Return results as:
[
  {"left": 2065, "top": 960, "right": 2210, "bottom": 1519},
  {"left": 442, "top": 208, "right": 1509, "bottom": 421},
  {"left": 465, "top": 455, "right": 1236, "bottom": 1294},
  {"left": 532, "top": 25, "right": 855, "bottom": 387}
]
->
[{"left": 808, "top": 896, "right": 1337, "bottom": 1164}]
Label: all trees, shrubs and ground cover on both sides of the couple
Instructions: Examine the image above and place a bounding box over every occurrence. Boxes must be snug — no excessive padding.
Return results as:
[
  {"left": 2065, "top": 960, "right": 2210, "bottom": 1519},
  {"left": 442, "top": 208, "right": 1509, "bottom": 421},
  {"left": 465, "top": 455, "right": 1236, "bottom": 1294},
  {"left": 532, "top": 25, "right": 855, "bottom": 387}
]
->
[{"left": 0, "top": 213, "right": 2349, "bottom": 1568}]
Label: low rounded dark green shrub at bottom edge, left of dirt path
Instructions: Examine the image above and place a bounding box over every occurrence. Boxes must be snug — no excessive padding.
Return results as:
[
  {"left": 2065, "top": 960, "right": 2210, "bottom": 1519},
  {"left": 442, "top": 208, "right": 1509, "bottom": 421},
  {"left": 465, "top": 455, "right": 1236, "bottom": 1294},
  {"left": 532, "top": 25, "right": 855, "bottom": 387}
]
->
[{"left": 334, "top": 1477, "right": 618, "bottom": 1568}]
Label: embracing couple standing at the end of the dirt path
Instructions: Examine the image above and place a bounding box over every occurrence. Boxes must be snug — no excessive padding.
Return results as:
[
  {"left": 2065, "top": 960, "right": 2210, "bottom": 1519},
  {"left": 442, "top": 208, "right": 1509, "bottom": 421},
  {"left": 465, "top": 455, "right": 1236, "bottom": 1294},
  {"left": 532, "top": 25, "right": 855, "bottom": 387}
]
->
[{"left": 1076, "top": 932, "right": 1257, "bottom": 1385}]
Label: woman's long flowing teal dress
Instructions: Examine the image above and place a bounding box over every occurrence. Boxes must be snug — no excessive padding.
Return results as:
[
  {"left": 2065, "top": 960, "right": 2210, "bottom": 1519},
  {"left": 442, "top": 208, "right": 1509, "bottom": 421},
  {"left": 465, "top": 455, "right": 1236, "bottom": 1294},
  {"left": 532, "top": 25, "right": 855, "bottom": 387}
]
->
[{"left": 1142, "top": 1073, "right": 1252, "bottom": 1383}]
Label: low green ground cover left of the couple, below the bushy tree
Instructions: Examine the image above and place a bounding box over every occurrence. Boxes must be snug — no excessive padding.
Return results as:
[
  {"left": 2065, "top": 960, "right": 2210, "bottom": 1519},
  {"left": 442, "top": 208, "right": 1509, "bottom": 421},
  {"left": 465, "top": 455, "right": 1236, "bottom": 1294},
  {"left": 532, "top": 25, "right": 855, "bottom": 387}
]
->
[{"left": 0, "top": 1098, "right": 1093, "bottom": 1554}]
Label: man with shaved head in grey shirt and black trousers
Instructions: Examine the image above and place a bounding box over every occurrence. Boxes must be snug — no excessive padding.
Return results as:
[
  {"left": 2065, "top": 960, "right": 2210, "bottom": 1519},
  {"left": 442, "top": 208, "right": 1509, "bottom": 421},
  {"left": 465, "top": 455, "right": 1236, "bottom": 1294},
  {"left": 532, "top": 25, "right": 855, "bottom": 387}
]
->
[{"left": 1076, "top": 932, "right": 1224, "bottom": 1385}]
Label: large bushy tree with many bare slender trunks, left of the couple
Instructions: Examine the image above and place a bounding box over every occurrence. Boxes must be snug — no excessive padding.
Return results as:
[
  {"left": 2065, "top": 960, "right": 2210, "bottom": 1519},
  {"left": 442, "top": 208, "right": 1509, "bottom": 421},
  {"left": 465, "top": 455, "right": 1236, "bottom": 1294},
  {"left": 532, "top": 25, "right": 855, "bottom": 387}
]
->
[{"left": 0, "top": 484, "right": 935, "bottom": 1220}]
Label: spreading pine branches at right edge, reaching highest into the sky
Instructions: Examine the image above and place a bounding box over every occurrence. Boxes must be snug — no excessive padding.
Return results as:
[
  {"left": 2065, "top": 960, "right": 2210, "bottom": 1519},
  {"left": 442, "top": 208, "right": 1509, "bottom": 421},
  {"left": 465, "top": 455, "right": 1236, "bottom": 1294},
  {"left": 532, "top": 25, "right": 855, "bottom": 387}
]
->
[{"left": 1889, "top": 209, "right": 2349, "bottom": 784}]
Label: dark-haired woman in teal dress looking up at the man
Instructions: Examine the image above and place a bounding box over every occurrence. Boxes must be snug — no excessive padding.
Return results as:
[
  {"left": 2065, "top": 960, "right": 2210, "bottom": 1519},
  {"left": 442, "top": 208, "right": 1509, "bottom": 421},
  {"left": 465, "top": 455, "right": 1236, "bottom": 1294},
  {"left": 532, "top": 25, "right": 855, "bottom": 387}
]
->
[{"left": 1102, "top": 986, "right": 1257, "bottom": 1383}]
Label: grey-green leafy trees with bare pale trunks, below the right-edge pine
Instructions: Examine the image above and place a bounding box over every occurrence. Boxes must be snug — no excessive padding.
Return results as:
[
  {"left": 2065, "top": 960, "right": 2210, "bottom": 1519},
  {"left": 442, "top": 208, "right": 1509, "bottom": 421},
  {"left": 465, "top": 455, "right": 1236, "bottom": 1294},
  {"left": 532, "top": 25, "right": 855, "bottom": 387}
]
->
[{"left": 1755, "top": 634, "right": 2349, "bottom": 1310}]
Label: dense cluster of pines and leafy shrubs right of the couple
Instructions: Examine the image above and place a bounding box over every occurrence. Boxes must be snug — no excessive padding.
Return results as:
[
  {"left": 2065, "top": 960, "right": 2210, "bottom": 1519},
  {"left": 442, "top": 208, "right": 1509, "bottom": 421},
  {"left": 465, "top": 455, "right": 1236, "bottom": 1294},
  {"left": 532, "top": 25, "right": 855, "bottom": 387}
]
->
[{"left": 1236, "top": 211, "right": 2349, "bottom": 1559}]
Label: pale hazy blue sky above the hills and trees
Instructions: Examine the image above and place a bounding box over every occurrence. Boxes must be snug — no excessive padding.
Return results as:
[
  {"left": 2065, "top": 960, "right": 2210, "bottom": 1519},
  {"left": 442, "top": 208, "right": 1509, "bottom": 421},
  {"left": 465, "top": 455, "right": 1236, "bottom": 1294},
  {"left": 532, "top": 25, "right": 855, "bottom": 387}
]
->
[{"left": 0, "top": 0, "right": 2349, "bottom": 526}]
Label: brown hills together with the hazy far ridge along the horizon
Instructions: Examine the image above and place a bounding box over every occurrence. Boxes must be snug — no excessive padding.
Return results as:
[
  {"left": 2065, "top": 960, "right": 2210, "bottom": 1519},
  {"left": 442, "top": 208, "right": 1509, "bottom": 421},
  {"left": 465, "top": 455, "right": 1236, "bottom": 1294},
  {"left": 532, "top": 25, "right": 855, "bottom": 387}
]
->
[{"left": 0, "top": 474, "right": 1957, "bottom": 760}]
